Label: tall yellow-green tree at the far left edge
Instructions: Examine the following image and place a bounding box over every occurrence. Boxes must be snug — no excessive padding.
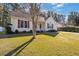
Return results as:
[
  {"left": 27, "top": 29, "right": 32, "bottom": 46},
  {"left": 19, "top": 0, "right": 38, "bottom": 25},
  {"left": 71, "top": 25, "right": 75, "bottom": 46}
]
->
[{"left": 0, "top": 3, "right": 17, "bottom": 27}]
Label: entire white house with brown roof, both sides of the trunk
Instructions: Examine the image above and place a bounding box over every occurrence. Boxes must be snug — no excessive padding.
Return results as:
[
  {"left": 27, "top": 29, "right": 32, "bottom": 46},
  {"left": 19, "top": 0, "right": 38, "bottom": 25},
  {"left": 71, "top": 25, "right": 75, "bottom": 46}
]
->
[{"left": 10, "top": 11, "right": 62, "bottom": 32}]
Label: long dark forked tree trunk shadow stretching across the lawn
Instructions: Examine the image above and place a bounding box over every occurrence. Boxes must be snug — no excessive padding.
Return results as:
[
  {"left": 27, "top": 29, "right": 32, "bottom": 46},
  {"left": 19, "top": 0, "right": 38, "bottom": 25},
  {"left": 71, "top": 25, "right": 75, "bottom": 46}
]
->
[{"left": 5, "top": 37, "right": 34, "bottom": 56}]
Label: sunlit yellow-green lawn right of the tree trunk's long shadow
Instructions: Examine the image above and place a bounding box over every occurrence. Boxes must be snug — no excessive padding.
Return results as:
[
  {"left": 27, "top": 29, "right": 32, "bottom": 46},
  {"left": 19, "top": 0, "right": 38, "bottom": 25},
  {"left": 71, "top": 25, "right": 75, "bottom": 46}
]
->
[{"left": 18, "top": 32, "right": 79, "bottom": 56}]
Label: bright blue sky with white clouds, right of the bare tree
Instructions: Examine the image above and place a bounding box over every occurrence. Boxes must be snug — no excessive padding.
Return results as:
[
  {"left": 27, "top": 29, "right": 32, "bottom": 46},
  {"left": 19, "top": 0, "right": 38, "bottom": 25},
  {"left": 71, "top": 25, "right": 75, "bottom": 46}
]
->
[{"left": 41, "top": 3, "right": 79, "bottom": 20}]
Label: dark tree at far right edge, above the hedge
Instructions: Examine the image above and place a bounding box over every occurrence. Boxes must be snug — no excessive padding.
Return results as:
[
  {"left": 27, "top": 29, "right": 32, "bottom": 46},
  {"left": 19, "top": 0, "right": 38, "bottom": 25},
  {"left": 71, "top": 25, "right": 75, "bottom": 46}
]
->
[{"left": 68, "top": 11, "right": 79, "bottom": 26}]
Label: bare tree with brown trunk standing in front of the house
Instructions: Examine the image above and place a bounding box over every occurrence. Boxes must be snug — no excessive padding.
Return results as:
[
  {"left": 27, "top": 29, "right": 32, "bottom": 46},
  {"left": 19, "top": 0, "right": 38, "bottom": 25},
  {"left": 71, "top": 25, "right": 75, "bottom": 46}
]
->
[{"left": 30, "top": 3, "right": 40, "bottom": 38}]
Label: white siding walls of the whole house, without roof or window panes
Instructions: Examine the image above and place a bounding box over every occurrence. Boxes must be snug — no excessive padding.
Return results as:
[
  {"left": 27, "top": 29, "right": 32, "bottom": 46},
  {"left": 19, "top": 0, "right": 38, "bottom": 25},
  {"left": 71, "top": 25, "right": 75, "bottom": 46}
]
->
[{"left": 11, "top": 16, "right": 62, "bottom": 32}]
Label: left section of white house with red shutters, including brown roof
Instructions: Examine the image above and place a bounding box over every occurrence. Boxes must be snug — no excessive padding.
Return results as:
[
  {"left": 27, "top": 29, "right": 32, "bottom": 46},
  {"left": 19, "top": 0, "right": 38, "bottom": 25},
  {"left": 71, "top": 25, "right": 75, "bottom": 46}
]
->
[{"left": 10, "top": 11, "right": 32, "bottom": 32}]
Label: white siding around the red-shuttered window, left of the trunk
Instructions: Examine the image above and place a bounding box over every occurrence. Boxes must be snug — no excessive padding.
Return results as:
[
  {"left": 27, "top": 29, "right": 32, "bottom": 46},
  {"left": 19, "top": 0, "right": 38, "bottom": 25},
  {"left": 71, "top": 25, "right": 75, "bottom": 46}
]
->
[{"left": 11, "top": 16, "right": 32, "bottom": 32}]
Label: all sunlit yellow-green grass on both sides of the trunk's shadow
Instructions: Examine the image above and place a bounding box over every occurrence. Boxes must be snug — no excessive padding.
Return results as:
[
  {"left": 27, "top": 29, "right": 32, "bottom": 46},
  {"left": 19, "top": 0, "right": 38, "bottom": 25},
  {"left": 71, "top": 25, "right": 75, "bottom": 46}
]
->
[{"left": 0, "top": 32, "right": 79, "bottom": 56}]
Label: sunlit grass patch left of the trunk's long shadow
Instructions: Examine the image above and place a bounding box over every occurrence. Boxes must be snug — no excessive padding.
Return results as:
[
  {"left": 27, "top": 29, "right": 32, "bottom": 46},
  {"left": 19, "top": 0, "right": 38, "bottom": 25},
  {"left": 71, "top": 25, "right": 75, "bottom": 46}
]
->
[{"left": 0, "top": 36, "right": 31, "bottom": 55}]
